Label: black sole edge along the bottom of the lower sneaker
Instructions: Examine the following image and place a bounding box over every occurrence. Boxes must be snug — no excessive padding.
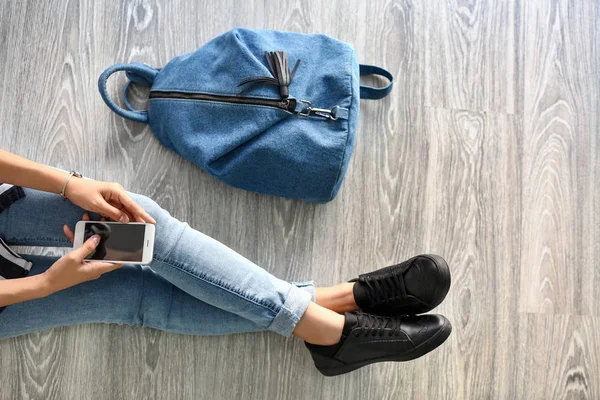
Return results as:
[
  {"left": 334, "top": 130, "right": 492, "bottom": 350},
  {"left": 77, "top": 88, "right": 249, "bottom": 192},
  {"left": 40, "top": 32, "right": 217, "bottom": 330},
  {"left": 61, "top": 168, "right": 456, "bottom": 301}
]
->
[{"left": 317, "top": 319, "right": 452, "bottom": 376}]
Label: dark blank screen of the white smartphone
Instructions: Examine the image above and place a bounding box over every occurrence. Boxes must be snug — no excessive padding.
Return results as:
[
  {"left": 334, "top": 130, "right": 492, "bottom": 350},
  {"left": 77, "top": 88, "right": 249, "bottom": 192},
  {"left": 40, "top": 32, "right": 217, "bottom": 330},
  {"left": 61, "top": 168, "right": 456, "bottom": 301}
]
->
[{"left": 83, "top": 222, "right": 146, "bottom": 262}]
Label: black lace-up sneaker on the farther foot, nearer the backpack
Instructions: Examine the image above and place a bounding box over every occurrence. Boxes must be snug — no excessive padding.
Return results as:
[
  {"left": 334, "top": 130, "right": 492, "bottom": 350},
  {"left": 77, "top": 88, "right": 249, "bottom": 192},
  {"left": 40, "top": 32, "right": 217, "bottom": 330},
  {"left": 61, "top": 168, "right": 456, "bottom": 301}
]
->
[{"left": 350, "top": 254, "right": 450, "bottom": 315}]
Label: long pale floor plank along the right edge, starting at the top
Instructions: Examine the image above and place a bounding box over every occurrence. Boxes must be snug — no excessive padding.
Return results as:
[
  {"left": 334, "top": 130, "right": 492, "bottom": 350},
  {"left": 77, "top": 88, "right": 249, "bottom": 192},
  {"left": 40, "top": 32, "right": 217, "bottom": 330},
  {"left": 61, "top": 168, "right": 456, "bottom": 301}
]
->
[{"left": 519, "top": 1, "right": 600, "bottom": 315}]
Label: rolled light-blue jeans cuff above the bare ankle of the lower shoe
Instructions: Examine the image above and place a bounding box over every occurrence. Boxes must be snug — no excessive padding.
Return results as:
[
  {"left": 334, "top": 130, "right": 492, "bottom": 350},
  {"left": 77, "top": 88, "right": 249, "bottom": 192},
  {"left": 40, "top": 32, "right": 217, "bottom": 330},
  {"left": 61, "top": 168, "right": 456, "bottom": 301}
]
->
[{"left": 268, "top": 282, "right": 315, "bottom": 336}]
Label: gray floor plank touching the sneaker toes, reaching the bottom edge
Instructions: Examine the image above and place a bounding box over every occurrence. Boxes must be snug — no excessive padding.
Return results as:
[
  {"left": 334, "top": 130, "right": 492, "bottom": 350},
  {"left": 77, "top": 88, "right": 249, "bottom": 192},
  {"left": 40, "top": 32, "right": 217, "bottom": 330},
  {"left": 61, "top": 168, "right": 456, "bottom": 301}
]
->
[{"left": 418, "top": 109, "right": 520, "bottom": 399}]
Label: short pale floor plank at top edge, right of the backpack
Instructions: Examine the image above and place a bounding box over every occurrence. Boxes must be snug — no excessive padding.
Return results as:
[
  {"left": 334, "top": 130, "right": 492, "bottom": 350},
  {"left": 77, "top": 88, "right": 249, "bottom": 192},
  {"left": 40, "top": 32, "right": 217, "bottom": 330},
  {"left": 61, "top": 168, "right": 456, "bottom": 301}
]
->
[{"left": 415, "top": 0, "right": 521, "bottom": 114}]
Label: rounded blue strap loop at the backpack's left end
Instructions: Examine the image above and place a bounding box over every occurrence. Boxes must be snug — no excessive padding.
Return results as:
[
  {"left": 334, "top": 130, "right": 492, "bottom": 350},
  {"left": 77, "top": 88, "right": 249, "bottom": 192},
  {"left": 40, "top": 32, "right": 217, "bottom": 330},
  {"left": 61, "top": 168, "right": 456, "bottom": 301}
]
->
[{"left": 98, "top": 63, "right": 158, "bottom": 123}]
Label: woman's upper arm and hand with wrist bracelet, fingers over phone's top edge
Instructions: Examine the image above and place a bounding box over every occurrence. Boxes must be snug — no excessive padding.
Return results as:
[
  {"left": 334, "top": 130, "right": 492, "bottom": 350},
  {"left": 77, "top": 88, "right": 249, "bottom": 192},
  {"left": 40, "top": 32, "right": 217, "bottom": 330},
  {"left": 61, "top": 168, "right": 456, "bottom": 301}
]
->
[{"left": 0, "top": 149, "right": 156, "bottom": 224}]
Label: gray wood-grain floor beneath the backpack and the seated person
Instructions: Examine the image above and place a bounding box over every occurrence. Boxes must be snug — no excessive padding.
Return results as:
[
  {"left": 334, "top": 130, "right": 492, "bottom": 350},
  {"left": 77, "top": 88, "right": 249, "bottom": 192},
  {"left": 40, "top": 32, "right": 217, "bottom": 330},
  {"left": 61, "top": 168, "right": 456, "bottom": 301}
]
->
[{"left": 0, "top": 0, "right": 600, "bottom": 400}]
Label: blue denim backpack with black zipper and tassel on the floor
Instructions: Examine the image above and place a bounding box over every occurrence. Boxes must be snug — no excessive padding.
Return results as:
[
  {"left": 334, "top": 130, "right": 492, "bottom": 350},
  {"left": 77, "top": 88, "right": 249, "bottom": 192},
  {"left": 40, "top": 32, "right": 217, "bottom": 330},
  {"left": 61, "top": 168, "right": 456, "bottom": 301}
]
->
[{"left": 98, "top": 29, "right": 393, "bottom": 202}]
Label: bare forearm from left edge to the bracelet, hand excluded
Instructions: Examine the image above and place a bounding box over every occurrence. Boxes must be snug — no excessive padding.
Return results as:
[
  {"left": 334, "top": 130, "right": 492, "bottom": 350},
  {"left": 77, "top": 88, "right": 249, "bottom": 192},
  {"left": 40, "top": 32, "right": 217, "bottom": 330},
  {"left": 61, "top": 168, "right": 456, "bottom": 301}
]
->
[{"left": 0, "top": 149, "right": 69, "bottom": 193}]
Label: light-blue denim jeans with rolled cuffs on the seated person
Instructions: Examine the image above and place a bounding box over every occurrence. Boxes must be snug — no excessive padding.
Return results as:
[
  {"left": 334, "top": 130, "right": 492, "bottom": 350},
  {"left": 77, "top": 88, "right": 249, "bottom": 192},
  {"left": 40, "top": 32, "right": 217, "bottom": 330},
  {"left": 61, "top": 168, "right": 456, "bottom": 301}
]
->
[{"left": 0, "top": 189, "right": 315, "bottom": 338}]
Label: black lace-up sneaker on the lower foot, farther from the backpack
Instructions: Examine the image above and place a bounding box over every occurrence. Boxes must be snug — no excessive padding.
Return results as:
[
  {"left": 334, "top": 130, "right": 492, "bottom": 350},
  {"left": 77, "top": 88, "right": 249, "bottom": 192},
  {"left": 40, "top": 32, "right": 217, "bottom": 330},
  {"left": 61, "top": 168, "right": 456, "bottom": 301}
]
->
[{"left": 305, "top": 311, "right": 452, "bottom": 376}]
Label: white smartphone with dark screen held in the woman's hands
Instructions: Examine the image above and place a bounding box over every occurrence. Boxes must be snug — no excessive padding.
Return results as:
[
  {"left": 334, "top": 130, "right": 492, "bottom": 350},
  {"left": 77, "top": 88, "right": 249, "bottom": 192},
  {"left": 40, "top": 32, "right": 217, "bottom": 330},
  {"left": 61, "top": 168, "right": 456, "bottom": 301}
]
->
[{"left": 73, "top": 221, "right": 154, "bottom": 265}]
